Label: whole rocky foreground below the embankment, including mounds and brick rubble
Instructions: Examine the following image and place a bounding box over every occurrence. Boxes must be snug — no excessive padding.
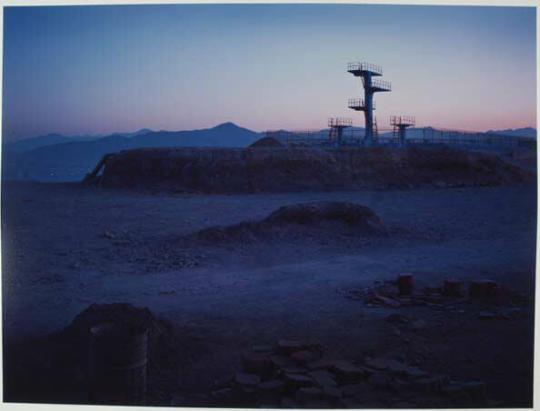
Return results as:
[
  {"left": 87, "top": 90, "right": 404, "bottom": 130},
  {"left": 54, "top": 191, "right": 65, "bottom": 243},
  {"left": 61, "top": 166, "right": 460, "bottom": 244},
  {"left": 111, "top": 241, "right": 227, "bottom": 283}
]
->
[{"left": 2, "top": 173, "right": 536, "bottom": 408}]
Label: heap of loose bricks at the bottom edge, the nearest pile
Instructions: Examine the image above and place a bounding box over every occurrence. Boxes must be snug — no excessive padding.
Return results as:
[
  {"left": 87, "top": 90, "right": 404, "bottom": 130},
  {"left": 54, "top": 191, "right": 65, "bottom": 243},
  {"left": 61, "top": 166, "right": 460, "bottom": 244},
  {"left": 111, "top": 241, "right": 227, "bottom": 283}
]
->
[{"left": 172, "top": 340, "right": 486, "bottom": 409}]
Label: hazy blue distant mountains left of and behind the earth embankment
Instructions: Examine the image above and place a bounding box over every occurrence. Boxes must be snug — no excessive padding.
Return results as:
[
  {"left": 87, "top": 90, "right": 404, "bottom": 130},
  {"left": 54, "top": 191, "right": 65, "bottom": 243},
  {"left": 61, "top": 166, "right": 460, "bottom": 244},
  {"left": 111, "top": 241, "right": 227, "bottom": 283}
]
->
[{"left": 2, "top": 123, "right": 261, "bottom": 181}]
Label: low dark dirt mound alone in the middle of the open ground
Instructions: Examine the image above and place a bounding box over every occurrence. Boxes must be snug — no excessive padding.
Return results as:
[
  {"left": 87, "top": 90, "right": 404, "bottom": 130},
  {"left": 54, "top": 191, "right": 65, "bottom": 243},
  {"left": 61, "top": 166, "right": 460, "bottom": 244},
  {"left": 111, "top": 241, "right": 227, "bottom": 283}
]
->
[{"left": 195, "top": 202, "right": 387, "bottom": 242}]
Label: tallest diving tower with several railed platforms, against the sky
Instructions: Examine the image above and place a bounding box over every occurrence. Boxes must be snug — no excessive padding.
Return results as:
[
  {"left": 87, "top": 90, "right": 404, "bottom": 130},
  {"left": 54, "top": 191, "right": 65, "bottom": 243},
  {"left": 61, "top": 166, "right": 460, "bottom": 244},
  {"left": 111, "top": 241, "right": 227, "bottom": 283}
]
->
[{"left": 347, "top": 62, "right": 392, "bottom": 145}]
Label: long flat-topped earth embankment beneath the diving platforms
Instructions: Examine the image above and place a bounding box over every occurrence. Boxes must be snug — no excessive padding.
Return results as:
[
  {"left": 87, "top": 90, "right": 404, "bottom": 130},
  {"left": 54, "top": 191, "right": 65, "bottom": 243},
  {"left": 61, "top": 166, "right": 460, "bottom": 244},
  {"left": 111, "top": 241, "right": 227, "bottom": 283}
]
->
[{"left": 90, "top": 147, "right": 532, "bottom": 193}]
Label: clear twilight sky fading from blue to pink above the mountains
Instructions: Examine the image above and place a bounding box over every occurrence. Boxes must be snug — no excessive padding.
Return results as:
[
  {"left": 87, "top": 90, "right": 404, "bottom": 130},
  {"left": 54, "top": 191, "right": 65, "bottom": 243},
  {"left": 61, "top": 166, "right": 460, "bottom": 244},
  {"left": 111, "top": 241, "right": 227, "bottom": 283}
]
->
[{"left": 2, "top": 4, "right": 536, "bottom": 140}]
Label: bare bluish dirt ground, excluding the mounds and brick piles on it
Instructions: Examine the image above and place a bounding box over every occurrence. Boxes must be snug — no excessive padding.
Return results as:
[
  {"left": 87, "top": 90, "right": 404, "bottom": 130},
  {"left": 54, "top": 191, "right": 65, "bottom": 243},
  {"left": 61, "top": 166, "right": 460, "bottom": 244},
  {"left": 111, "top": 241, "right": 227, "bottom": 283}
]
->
[{"left": 2, "top": 183, "right": 536, "bottom": 407}]
